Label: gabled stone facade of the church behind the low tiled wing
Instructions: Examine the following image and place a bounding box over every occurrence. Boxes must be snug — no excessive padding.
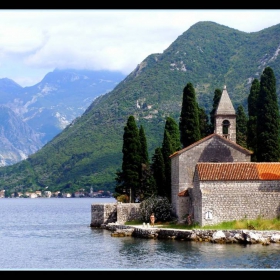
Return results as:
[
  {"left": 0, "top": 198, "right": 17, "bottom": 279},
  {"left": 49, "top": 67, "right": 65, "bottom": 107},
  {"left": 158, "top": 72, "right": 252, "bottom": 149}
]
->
[{"left": 171, "top": 134, "right": 251, "bottom": 221}]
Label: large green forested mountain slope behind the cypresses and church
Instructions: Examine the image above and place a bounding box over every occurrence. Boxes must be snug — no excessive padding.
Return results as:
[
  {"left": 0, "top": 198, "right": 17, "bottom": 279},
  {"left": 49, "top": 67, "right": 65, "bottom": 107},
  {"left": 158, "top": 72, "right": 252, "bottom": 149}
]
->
[{"left": 0, "top": 21, "right": 280, "bottom": 195}]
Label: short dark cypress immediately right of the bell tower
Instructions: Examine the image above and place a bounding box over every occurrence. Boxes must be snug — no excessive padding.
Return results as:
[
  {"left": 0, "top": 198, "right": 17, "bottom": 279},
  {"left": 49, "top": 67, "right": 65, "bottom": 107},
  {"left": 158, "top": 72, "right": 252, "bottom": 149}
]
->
[{"left": 236, "top": 105, "right": 248, "bottom": 148}]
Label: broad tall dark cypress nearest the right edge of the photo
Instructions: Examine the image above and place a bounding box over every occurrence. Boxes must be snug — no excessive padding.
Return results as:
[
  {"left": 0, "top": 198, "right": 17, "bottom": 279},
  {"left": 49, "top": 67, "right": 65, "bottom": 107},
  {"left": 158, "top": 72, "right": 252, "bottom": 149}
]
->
[{"left": 257, "top": 67, "right": 280, "bottom": 162}]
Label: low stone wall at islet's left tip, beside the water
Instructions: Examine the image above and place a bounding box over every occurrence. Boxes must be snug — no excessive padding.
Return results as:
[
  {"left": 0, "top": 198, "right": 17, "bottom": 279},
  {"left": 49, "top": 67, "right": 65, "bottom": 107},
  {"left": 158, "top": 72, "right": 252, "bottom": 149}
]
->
[{"left": 90, "top": 203, "right": 140, "bottom": 227}]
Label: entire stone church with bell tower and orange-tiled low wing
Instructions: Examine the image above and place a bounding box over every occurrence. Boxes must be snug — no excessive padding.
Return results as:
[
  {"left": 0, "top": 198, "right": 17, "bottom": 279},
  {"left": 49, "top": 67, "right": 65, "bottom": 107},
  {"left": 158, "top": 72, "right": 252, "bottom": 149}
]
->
[{"left": 170, "top": 86, "right": 280, "bottom": 226}]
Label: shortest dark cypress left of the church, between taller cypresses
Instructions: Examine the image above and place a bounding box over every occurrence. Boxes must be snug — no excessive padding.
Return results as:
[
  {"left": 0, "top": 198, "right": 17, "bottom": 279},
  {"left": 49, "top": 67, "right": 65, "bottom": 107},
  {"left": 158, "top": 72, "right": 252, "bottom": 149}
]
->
[{"left": 151, "top": 147, "right": 166, "bottom": 196}]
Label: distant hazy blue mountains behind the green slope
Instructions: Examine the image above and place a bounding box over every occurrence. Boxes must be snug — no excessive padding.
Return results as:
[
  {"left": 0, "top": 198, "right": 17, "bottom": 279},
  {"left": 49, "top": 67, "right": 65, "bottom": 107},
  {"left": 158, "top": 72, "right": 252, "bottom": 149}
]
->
[{"left": 0, "top": 69, "right": 125, "bottom": 166}]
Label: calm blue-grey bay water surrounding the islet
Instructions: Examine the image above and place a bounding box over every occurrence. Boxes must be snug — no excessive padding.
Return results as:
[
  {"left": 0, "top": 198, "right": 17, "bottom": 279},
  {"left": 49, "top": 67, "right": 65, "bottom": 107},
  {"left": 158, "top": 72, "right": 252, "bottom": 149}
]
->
[{"left": 0, "top": 198, "right": 280, "bottom": 270}]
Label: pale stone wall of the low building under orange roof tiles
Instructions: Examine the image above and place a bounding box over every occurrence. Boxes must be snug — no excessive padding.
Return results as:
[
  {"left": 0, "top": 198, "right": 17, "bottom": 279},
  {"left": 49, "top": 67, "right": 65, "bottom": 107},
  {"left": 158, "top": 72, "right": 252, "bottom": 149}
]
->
[{"left": 190, "top": 177, "right": 280, "bottom": 226}]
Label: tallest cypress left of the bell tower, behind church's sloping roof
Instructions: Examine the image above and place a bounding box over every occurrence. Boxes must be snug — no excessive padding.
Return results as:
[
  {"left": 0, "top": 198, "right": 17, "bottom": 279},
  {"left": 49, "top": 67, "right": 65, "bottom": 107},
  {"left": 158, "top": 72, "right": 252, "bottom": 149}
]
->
[{"left": 179, "top": 82, "right": 201, "bottom": 148}]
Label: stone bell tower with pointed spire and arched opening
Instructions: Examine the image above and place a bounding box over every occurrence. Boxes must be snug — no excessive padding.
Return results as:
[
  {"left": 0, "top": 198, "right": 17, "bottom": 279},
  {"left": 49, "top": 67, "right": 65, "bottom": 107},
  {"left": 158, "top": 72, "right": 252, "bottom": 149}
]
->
[{"left": 214, "top": 86, "right": 236, "bottom": 143}]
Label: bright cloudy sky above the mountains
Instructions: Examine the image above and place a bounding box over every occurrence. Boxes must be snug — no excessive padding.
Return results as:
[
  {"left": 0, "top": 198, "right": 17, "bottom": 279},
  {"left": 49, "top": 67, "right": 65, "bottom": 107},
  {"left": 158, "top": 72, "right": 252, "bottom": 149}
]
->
[{"left": 0, "top": 9, "right": 280, "bottom": 87}]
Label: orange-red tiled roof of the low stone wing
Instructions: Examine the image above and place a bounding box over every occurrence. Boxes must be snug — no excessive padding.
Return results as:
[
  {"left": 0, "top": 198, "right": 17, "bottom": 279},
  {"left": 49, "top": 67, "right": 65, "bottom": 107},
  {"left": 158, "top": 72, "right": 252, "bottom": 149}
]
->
[{"left": 196, "top": 162, "right": 280, "bottom": 181}]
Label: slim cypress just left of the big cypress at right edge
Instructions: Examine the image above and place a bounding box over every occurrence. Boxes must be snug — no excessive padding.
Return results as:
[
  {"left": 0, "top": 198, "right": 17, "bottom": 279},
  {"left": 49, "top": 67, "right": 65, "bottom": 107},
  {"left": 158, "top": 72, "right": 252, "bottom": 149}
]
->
[{"left": 247, "top": 79, "right": 260, "bottom": 162}]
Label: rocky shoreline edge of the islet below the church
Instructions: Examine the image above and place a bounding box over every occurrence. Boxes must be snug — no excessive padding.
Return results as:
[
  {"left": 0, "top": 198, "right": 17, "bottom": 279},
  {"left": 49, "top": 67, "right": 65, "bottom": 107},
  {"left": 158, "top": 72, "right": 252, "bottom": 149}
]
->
[{"left": 101, "top": 223, "right": 280, "bottom": 245}]
